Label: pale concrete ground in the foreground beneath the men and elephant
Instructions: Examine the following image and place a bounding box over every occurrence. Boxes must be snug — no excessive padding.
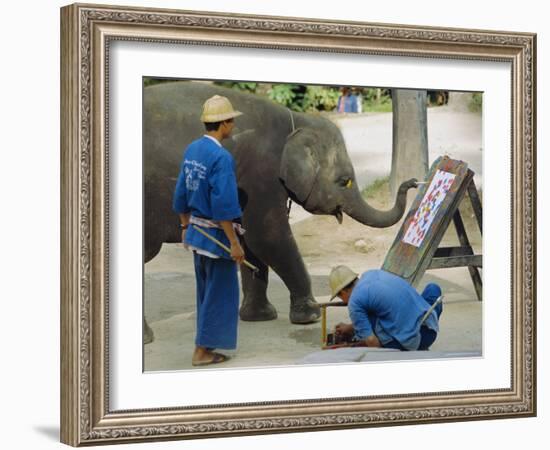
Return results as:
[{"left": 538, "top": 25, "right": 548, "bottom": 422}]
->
[{"left": 144, "top": 244, "right": 482, "bottom": 371}]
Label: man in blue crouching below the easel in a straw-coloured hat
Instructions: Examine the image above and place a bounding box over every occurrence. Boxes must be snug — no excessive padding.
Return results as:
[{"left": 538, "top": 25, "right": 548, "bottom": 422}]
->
[{"left": 329, "top": 266, "right": 443, "bottom": 350}]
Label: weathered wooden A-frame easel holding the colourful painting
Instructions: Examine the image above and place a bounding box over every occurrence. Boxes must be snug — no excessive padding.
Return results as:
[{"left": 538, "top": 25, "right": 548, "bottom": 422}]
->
[{"left": 382, "top": 157, "right": 483, "bottom": 301}]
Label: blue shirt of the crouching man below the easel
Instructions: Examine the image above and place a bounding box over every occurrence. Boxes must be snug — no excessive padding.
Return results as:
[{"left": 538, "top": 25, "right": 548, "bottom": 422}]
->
[{"left": 348, "top": 270, "right": 439, "bottom": 350}]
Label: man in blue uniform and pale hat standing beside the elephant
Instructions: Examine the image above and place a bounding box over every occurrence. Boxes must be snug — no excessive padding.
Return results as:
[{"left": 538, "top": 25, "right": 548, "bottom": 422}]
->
[{"left": 173, "top": 95, "right": 244, "bottom": 366}]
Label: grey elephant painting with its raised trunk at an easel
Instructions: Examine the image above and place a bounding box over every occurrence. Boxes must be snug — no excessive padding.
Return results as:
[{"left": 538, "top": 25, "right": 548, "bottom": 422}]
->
[{"left": 143, "top": 81, "right": 416, "bottom": 324}]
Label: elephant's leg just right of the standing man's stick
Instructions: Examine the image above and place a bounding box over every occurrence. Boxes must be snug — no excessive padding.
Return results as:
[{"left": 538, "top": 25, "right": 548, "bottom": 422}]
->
[{"left": 239, "top": 242, "right": 277, "bottom": 321}]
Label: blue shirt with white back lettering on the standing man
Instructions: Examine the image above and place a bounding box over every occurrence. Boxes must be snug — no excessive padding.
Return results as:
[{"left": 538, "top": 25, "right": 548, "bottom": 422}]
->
[{"left": 173, "top": 136, "right": 242, "bottom": 259}]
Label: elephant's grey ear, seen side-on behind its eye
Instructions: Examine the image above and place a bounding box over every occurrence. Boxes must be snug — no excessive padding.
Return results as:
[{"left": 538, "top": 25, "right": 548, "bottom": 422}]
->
[{"left": 279, "top": 128, "right": 320, "bottom": 204}]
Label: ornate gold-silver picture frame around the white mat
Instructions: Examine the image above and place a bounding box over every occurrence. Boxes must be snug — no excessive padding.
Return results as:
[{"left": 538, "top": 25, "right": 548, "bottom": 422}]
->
[{"left": 61, "top": 4, "right": 536, "bottom": 446}]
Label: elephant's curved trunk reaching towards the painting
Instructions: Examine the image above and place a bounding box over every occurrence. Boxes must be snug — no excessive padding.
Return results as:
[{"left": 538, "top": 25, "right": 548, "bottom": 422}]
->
[{"left": 342, "top": 179, "right": 416, "bottom": 228}]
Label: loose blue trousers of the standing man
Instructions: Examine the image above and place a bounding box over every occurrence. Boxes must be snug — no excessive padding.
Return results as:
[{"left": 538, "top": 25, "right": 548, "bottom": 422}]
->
[{"left": 193, "top": 252, "right": 239, "bottom": 349}]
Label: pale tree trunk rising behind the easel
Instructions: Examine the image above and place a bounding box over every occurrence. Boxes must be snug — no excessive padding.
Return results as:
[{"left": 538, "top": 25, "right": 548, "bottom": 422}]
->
[{"left": 390, "top": 89, "right": 428, "bottom": 198}]
